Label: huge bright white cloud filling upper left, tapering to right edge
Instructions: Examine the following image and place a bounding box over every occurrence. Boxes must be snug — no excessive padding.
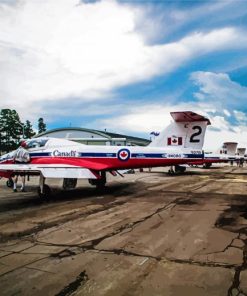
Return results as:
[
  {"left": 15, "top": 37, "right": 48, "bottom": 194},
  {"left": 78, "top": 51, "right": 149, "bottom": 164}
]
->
[{"left": 0, "top": 0, "right": 247, "bottom": 119}]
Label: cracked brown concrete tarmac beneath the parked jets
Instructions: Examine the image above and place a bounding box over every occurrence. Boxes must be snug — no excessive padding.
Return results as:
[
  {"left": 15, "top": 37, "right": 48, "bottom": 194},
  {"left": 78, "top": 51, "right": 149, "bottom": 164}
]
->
[{"left": 0, "top": 166, "right": 247, "bottom": 296}]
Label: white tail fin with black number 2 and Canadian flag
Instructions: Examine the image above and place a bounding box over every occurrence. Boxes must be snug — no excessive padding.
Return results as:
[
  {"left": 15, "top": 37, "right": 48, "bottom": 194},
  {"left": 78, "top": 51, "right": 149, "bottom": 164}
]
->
[{"left": 150, "top": 111, "right": 211, "bottom": 149}]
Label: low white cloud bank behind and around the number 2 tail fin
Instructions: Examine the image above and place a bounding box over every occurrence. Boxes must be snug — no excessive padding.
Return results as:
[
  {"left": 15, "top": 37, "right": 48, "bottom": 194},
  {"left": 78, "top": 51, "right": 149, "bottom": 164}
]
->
[{"left": 101, "top": 72, "right": 247, "bottom": 150}]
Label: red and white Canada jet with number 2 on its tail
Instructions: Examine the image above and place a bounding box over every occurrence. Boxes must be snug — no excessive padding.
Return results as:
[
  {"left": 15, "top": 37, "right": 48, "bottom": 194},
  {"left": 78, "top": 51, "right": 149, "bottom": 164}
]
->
[{"left": 0, "top": 111, "right": 210, "bottom": 198}]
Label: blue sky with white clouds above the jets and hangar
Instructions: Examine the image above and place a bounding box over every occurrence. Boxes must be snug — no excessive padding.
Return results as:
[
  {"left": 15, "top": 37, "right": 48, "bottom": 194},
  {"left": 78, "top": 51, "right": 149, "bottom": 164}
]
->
[{"left": 0, "top": 0, "right": 247, "bottom": 148}]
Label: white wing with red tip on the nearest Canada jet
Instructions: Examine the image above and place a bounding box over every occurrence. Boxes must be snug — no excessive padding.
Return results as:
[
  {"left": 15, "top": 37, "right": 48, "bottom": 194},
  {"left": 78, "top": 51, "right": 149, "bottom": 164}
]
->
[{"left": 0, "top": 164, "right": 100, "bottom": 179}]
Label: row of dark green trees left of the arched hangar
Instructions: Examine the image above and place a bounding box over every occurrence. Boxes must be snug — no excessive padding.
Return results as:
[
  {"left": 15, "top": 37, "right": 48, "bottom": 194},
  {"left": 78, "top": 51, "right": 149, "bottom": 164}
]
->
[{"left": 0, "top": 109, "right": 46, "bottom": 154}]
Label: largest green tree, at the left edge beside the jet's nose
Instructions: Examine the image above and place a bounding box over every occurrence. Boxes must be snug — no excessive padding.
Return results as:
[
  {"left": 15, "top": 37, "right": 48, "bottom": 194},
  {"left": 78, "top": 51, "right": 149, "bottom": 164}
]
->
[{"left": 0, "top": 109, "right": 24, "bottom": 152}]
